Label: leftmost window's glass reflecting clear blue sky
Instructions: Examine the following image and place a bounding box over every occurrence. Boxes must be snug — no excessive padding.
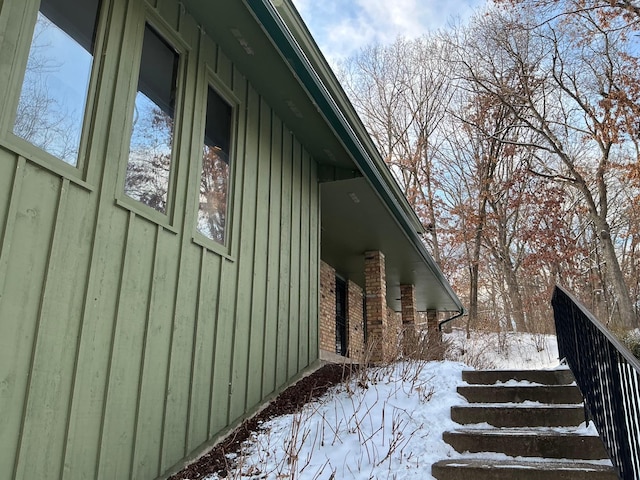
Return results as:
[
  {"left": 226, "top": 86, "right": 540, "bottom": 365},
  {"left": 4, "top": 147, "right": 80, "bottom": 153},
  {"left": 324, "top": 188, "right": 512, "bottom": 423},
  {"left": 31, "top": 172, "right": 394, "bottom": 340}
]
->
[{"left": 13, "top": 0, "right": 100, "bottom": 166}]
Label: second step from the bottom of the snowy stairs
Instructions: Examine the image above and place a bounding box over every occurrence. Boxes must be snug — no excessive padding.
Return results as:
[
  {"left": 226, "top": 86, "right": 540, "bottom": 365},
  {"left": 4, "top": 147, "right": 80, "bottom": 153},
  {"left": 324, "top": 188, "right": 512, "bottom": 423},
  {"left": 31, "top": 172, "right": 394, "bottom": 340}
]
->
[{"left": 442, "top": 428, "right": 608, "bottom": 460}]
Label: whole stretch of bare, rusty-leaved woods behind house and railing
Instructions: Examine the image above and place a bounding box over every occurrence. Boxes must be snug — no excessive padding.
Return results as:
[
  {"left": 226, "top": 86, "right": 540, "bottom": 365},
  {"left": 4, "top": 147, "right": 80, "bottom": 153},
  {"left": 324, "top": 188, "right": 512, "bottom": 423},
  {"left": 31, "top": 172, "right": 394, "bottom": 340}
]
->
[{"left": 338, "top": 0, "right": 640, "bottom": 332}]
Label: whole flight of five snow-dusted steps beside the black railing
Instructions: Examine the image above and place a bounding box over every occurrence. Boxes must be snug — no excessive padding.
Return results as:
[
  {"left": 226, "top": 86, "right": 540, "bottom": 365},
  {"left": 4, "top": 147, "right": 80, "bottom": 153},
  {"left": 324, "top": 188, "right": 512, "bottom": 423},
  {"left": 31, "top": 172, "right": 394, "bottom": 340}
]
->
[{"left": 431, "top": 369, "right": 618, "bottom": 480}]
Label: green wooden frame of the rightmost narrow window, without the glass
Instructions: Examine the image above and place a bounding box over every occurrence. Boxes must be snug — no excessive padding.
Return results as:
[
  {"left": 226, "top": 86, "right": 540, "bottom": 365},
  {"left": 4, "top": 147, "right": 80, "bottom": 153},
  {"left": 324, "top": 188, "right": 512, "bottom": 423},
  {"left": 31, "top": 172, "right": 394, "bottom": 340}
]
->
[{"left": 189, "top": 71, "right": 242, "bottom": 261}]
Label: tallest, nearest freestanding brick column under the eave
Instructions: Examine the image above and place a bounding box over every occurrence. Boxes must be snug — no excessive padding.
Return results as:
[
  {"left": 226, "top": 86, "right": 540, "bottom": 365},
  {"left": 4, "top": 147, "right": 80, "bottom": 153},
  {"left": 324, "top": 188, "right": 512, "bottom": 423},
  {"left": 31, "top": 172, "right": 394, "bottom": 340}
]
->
[{"left": 364, "top": 251, "right": 390, "bottom": 362}]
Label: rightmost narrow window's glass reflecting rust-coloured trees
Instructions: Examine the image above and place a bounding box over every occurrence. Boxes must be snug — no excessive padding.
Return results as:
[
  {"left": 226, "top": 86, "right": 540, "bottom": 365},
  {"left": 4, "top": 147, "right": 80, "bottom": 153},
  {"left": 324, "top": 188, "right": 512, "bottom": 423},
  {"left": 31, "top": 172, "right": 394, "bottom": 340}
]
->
[{"left": 198, "top": 87, "right": 232, "bottom": 244}]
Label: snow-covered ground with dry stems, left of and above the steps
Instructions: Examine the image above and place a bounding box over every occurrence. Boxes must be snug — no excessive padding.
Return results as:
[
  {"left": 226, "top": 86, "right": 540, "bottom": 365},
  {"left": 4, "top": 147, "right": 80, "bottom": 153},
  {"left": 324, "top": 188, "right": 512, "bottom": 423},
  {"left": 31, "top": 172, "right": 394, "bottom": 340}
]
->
[{"left": 207, "top": 331, "right": 558, "bottom": 480}]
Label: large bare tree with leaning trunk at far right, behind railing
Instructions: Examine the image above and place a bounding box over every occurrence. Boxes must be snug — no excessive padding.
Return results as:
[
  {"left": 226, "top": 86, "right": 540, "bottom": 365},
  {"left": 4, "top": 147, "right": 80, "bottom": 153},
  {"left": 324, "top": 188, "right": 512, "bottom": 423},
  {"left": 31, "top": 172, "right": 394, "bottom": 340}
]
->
[{"left": 459, "top": 4, "right": 638, "bottom": 326}]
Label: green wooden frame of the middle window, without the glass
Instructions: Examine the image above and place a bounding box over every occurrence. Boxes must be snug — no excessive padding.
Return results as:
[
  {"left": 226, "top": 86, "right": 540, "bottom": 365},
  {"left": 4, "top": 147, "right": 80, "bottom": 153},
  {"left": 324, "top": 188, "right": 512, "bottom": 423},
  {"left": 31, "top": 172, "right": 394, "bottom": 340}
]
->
[{"left": 115, "top": 15, "right": 191, "bottom": 233}]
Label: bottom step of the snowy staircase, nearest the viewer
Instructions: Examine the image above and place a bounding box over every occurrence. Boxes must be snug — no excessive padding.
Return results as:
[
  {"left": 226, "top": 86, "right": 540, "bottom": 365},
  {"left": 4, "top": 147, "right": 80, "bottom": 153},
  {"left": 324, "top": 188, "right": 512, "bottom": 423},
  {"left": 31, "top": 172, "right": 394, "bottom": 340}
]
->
[{"left": 431, "top": 458, "right": 618, "bottom": 480}]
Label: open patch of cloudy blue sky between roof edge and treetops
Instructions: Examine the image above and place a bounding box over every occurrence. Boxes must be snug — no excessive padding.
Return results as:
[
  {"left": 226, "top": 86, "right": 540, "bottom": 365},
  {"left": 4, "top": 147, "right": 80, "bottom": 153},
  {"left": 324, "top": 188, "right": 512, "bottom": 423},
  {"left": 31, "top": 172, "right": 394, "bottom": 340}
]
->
[{"left": 293, "top": 0, "right": 486, "bottom": 63}]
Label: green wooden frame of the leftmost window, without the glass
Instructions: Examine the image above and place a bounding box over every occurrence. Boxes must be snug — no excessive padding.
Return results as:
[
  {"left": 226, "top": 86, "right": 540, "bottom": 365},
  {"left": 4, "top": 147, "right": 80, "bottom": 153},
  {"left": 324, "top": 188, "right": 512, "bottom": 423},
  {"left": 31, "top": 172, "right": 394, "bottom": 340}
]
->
[{"left": 0, "top": 0, "right": 107, "bottom": 191}]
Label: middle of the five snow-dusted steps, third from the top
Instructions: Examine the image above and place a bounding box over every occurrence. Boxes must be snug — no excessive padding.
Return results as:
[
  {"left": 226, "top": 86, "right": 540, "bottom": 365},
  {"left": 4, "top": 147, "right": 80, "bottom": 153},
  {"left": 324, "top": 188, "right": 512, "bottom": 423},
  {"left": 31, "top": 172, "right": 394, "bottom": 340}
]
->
[{"left": 451, "top": 403, "right": 585, "bottom": 427}]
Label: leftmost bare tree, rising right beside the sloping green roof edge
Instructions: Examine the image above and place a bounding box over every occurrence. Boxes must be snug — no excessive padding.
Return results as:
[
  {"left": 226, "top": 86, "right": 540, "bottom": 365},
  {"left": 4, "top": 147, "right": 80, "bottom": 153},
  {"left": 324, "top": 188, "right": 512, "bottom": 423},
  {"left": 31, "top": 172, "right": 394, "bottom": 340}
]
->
[{"left": 339, "top": 35, "right": 455, "bottom": 266}]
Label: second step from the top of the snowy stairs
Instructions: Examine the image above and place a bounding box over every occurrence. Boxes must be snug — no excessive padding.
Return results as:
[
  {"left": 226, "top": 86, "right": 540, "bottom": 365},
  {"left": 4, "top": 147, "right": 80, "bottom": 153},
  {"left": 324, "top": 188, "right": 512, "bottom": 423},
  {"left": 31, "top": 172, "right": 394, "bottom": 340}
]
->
[{"left": 458, "top": 384, "right": 582, "bottom": 403}]
